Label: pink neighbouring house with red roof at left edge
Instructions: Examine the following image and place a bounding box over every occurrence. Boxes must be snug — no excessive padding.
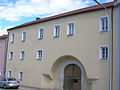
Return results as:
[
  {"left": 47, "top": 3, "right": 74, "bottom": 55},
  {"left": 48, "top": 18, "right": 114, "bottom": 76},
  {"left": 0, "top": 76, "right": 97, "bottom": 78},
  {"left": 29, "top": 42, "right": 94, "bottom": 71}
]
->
[{"left": 0, "top": 35, "right": 8, "bottom": 77}]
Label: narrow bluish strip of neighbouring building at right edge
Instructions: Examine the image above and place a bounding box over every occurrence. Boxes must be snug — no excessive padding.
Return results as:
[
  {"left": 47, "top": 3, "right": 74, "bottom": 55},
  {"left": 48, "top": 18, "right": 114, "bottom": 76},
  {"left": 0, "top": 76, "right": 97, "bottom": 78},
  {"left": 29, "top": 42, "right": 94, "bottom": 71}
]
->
[{"left": 113, "top": 0, "right": 120, "bottom": 90}]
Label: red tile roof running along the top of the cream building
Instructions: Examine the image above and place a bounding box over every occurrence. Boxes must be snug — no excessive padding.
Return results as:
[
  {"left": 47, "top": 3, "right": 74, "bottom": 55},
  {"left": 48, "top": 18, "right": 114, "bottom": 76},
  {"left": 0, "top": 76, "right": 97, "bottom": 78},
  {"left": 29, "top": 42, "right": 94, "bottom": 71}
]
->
[{"left": 8, "top": 2, "right": 114, "bottom": 30}]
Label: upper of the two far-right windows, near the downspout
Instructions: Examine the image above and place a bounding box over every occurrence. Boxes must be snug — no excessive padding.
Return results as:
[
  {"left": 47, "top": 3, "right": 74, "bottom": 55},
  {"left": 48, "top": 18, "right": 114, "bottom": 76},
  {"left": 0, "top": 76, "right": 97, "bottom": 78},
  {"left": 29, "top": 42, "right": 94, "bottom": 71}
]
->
[{"left": 100, "top": 16, "right": 108, "bottom": 32}]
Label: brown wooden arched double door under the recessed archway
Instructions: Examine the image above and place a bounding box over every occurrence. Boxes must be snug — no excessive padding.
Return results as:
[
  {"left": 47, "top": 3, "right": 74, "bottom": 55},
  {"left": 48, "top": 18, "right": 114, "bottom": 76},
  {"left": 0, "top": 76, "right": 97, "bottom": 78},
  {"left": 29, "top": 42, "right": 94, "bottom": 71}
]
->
[{"left": 63, "top": 64, "right": 81, "bottom": 90}]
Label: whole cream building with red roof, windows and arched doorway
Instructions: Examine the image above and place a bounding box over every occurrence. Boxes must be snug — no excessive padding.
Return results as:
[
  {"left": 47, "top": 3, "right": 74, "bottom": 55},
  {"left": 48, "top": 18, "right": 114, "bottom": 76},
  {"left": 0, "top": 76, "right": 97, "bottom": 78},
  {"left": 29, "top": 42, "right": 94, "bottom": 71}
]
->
[{"left": 6, "top": 2, "right": 117, "bottom": 90}]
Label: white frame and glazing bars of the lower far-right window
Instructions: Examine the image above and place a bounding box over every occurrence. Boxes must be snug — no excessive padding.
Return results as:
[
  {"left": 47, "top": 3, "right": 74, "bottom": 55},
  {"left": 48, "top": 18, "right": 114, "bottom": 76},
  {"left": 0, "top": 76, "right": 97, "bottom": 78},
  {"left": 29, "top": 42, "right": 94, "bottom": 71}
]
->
[{"left": 99, "top": 45, "right": 109, "bottom": 61}]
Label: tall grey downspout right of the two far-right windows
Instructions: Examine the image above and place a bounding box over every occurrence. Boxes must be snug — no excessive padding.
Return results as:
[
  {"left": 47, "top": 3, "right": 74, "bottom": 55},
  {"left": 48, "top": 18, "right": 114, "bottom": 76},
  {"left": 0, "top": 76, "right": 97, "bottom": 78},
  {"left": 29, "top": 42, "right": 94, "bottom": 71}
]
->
[{"left": 109, "top": 7, "right": 114, "bottom": 90}]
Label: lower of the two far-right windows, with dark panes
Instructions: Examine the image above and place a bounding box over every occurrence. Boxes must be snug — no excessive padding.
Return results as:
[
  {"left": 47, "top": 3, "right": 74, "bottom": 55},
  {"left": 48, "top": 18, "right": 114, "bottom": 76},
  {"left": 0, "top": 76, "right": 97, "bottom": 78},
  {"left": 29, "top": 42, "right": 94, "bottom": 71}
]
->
[{"left": 99, "top": 45, "right": 109, "bottom": 60}]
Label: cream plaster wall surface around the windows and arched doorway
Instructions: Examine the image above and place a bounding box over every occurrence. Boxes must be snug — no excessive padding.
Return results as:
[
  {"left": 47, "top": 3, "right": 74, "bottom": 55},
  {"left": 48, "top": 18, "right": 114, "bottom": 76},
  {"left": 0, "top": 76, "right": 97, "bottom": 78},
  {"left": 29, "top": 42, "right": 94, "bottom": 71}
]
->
[{"left": 7, "top": 10, "right": 110, "bottom": 90}]
